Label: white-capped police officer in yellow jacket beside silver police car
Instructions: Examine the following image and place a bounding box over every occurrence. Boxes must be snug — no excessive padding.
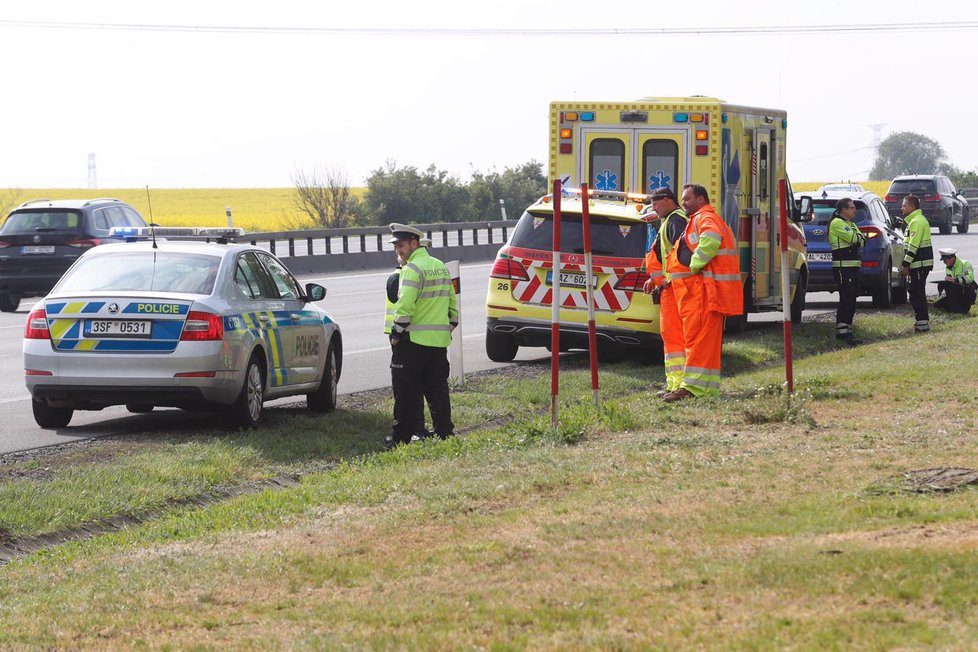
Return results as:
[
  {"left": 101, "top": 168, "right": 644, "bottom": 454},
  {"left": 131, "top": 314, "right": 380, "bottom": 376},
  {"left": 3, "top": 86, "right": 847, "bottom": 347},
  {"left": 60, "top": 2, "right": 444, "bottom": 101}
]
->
[{"left": 390, "top": 223, "right": 458, "bottom": 445}]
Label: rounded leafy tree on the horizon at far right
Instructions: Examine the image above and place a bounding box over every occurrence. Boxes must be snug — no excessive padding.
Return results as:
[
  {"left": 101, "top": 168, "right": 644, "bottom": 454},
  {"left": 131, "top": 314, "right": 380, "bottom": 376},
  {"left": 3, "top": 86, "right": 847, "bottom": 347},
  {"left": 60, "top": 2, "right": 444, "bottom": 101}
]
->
[{"left": 869, "top": 131, "right": 978, "bottom": 188}]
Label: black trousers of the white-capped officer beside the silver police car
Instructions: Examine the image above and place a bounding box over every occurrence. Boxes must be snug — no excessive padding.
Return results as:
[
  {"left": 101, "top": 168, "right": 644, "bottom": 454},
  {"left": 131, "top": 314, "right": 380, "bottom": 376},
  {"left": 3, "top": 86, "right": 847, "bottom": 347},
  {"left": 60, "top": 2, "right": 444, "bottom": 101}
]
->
[{"left": 391, "top": 339, "right": 455, "bottom": 443}]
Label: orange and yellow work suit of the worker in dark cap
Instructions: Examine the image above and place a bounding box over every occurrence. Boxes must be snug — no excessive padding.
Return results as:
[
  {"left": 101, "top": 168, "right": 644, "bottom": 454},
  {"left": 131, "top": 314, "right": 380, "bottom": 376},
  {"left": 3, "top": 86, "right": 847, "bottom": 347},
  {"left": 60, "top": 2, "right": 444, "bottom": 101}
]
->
[{"left": 645, "top": 209, "right": 686, "bottom": 392}]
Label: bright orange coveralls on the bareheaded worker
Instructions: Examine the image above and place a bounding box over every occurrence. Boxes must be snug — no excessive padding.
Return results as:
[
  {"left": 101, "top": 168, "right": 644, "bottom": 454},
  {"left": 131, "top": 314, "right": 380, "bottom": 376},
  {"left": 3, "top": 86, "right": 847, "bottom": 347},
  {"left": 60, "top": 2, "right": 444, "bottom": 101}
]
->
[{"left": 666, "top": 204, "right": 744, "bottom": 396}]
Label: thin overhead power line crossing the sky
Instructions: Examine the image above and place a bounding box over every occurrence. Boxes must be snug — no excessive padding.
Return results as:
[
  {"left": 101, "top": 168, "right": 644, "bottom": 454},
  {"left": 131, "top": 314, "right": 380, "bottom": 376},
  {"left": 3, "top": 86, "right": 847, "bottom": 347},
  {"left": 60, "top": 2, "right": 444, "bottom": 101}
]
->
[{"left": 0, "top": 20, "right": 978, "bottom": 37}]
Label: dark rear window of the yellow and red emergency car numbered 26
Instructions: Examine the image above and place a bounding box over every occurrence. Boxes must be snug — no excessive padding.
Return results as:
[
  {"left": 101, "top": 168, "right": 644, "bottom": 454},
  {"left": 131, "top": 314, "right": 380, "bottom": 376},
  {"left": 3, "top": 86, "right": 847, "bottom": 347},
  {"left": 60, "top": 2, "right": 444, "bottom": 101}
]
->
[{"left": 510, "top": 211, "right": 647, "bottom": 258}]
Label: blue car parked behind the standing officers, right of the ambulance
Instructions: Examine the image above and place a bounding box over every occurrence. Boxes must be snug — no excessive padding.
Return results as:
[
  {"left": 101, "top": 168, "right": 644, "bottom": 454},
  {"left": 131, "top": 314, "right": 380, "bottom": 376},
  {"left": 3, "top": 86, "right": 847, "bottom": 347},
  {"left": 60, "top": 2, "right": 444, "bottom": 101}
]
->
[{"left": 800, "top": 192, "right": 907, "bottom": 308}]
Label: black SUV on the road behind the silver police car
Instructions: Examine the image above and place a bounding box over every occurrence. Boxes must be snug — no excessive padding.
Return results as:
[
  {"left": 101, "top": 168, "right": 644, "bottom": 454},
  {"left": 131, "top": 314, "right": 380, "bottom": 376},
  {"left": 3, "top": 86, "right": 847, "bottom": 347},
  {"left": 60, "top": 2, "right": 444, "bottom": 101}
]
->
[{"left": 0, "top": 199, "right": 146, "bottom": 312}]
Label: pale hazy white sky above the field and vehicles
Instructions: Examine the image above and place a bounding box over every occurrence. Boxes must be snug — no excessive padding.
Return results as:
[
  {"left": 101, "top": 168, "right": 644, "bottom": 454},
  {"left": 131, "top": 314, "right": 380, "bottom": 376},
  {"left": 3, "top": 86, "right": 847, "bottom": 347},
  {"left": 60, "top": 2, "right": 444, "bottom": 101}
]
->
[{"left": 0, "top": 0, "right": 978, "bottom": 188}]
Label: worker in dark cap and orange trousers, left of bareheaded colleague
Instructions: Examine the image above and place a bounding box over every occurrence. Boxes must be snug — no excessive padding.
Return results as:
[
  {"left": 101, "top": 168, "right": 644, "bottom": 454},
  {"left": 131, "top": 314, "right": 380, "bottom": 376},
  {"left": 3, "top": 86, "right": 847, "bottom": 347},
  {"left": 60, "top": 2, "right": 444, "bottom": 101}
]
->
[{"left": 643, "top": 187, "right": 687, "bottom": 398}]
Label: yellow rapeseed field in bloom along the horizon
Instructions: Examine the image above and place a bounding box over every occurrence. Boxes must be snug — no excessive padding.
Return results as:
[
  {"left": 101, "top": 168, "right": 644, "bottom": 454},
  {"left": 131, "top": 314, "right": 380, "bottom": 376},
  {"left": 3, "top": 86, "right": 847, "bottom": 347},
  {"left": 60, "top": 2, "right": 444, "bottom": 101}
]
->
[{"left": 7, "top": 181, "right": 876, "bottom": 231}]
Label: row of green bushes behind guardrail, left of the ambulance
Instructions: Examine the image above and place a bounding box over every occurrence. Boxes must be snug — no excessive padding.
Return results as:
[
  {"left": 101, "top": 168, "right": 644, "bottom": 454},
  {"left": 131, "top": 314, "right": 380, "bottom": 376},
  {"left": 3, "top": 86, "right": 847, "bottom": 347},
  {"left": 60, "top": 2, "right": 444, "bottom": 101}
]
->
[{"left": 292, "top": 160, "right": 547, "bottom": 228}]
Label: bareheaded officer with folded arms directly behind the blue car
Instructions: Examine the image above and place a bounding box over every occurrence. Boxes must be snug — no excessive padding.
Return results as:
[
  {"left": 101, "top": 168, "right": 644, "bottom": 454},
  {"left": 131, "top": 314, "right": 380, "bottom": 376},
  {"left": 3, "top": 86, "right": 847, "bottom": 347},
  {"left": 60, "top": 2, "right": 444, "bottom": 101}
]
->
[{"left": 829, "top": 198, "right": 866, "bottom": 345}]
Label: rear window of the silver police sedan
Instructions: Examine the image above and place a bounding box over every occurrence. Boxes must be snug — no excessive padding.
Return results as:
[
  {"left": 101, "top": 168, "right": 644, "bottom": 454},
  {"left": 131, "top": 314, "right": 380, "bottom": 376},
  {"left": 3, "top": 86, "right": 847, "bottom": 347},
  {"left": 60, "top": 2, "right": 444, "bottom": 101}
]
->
[{"left": 54, "top": 251, "right": 221, "bottom": 294}]
